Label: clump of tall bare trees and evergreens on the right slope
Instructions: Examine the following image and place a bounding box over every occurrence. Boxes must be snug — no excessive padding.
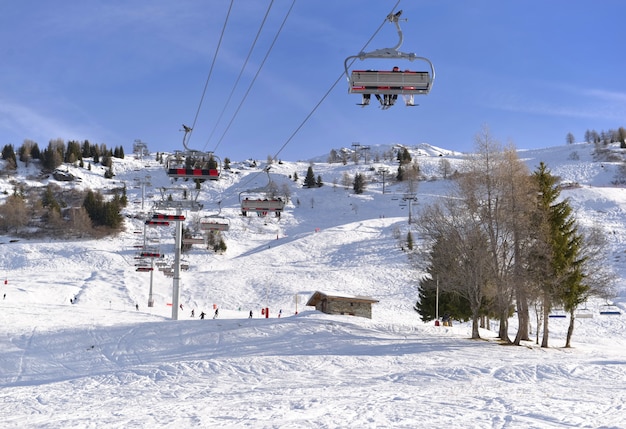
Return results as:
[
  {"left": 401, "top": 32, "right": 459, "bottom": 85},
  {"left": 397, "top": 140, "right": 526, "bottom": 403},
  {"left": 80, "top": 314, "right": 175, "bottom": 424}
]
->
[{"left": 415, "top": 129, "right": 612, "bottom": 347}]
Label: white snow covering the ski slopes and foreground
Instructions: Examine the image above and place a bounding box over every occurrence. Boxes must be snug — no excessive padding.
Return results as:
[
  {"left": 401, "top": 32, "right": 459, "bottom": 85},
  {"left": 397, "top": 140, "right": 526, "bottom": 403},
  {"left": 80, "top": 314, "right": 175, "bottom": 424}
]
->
[{"left": 0, "top": 144, "right": 626, "bottom": 428}]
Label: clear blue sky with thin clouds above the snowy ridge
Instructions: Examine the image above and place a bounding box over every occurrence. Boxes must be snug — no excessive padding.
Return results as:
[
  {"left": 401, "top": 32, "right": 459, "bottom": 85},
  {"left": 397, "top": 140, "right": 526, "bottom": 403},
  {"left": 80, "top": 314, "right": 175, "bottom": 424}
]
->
[{"left": 0, "top": 0, "right": 626, "bottom": 160}]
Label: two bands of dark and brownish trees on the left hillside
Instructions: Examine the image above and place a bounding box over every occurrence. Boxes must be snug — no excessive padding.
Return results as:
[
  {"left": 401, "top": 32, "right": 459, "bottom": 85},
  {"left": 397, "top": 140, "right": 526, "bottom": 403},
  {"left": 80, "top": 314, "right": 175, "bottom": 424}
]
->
[{"left": 0, "top": 139, "right": 127, "bottom": 237}]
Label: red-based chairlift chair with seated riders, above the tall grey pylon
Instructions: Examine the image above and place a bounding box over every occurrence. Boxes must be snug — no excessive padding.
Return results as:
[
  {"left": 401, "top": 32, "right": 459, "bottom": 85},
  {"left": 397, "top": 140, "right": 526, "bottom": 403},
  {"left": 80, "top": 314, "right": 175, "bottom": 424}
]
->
[{"left": 166, "top": 125, "right": 221, "bottom": 180}]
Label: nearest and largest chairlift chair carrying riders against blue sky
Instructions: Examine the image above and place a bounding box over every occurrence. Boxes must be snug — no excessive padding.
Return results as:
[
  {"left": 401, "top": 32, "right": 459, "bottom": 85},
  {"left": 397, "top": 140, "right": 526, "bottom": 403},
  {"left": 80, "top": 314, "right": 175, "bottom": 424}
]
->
[{"left": 344, "top": 11, "right": 435, "bottom": 110}]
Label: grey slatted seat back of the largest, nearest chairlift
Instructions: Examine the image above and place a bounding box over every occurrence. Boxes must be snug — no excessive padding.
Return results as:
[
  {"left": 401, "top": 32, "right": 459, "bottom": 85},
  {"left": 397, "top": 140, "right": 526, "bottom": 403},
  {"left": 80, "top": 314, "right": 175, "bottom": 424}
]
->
[{"left": 350, "top": 70, "right": 432, "bottom": 95}]
